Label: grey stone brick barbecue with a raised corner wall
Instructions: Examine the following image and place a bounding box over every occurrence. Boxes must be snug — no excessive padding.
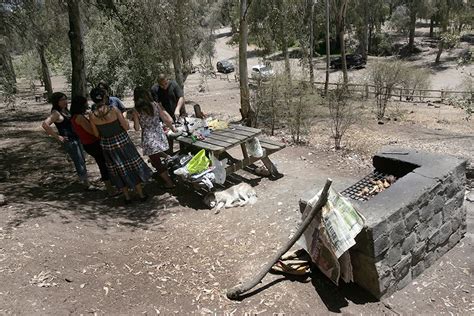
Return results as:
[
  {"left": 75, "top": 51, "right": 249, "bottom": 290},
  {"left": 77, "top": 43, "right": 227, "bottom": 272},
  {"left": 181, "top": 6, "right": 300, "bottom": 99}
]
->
[{"left": 300, "top": 148, "right": 466, "bottom": 299}]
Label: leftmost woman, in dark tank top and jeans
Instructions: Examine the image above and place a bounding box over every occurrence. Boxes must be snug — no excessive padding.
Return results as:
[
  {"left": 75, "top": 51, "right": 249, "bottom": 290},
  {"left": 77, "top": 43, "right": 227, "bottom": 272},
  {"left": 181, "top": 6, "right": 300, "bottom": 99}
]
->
[{"left": 41, "top": 92, "right": 91, "bottom": 188}]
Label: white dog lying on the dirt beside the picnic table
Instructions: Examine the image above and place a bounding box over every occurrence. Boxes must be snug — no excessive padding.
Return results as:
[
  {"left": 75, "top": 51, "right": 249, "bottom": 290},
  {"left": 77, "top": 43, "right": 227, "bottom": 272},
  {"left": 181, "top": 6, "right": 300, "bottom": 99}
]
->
[{"left": 204, "top": 182, "right": 257, "bottom": 214}]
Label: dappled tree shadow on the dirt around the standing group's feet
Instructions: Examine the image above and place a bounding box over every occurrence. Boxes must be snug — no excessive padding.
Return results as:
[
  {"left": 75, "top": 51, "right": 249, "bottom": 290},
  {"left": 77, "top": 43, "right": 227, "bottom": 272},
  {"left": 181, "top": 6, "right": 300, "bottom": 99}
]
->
[{"left": 0, "top": 127, "right": 183, "bottom": 229}]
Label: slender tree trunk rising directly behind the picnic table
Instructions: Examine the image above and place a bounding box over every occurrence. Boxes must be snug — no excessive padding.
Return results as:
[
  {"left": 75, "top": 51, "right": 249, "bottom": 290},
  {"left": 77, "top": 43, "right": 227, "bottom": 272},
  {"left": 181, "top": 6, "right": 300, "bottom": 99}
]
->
[{"left": 239, "top": 0, "right": 255, "bottom": 126}]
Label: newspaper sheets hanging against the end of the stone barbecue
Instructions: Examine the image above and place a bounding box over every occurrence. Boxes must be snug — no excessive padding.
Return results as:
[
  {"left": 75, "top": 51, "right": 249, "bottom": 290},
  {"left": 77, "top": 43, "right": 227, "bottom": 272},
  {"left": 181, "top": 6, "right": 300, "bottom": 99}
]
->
[{"left": 299, "top": 189, "right": 365, "bottom": 285}]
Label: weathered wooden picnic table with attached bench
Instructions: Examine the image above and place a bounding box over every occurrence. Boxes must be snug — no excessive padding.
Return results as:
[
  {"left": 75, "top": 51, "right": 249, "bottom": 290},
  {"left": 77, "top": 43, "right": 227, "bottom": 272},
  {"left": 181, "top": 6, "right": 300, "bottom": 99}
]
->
[{"left": 177, "top": 125, "right": 285, "bottom": 179}]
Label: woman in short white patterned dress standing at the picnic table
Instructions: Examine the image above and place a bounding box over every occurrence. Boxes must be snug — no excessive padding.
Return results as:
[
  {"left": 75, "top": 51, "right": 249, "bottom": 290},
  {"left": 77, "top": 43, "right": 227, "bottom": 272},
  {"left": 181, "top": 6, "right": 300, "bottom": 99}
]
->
[{"left": 132, "top": 87, "right": 176, "bottom": 189}]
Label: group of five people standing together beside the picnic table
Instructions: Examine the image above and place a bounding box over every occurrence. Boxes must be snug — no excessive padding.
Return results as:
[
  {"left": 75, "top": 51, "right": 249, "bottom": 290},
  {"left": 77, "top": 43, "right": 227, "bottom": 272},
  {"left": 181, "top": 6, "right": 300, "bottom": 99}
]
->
[{"left": 42, "top": 75, "right": 186, "bottom": 204}]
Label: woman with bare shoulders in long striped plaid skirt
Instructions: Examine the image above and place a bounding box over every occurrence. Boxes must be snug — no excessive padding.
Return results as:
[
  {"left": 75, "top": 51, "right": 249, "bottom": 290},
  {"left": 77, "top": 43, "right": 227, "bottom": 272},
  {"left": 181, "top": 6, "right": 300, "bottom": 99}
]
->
[{"left": 89, "top": 89, "right": 152, "bottom": 204}]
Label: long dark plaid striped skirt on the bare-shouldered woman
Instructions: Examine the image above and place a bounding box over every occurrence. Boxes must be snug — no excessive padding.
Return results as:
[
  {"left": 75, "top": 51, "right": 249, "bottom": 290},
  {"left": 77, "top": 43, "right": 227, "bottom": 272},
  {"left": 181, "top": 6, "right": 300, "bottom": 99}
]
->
[{"left": 100, "top": 131, "right": 152, "bottom": 189}]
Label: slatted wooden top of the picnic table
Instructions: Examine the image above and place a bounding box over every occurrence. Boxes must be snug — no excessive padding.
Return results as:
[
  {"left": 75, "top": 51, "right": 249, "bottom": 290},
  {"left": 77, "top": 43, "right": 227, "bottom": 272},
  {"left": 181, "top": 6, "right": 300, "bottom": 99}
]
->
[{"left": 177, "top": 125, "right": 262, "bottom": 152}]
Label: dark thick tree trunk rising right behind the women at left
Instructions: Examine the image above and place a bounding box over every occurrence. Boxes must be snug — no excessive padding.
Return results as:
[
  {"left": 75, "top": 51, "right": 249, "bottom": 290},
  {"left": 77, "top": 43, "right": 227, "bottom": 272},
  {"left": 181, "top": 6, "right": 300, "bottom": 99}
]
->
[{"left": 67, "top": 0, "right": 87, "bottom": 98}]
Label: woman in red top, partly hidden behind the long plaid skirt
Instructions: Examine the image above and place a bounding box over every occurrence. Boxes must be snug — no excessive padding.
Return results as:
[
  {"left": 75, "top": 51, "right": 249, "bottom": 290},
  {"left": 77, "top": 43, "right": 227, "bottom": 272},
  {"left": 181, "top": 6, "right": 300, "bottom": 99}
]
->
[{"left": 70, "top": 96, "right": 119, "bottom": 196}]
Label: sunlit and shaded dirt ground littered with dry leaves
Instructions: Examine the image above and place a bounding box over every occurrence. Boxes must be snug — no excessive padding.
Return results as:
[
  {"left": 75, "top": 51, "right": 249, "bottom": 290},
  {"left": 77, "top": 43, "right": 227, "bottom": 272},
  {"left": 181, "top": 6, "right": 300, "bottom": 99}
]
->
[{"left": 0, "top": 29, "right": 474, "bottom": 315}]
